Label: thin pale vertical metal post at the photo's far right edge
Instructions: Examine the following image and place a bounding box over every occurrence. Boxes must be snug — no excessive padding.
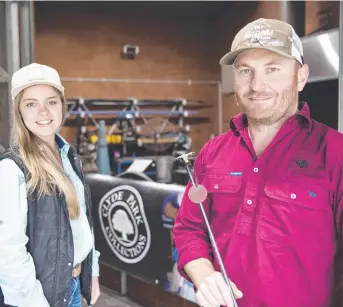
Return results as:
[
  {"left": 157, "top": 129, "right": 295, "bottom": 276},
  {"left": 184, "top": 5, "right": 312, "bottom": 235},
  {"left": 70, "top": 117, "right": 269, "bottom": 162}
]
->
[{"left": 338, "top": 1, "right": 343, "bottom": 132}]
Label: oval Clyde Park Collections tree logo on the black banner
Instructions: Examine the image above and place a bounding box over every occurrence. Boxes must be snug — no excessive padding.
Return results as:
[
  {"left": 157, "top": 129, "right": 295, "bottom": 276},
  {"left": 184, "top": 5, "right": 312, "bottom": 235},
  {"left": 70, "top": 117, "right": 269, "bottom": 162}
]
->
[{"left": 99, "top": 185, "right": 151, "bottom": 263}]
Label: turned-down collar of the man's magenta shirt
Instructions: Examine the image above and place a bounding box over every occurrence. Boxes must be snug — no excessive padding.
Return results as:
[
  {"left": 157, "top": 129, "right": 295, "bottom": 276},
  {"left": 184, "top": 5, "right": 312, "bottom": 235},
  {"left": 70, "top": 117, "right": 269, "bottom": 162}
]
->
[{"left": 230, "top": 102, "right": 312, "bottom": 134}]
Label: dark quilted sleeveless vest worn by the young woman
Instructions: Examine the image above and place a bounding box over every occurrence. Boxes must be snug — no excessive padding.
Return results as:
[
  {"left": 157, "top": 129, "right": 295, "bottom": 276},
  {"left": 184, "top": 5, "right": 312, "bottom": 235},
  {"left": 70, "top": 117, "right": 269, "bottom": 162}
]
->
[{"left": 0, "top": 146, "right": 93, "bottom": 307}]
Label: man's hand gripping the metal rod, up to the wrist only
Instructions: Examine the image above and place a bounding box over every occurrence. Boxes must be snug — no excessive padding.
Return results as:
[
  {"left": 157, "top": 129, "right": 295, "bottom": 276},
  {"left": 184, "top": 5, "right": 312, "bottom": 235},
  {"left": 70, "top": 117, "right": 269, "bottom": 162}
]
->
[{"left": 196, "top": 272, "right": 243, "bottom": 307}]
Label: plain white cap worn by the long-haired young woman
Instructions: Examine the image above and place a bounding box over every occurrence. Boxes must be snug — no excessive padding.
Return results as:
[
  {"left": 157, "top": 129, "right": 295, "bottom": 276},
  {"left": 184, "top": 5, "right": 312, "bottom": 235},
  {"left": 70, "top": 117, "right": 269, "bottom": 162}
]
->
[{"left": 11, "top": 63, "right": 64, "bottom": 100}]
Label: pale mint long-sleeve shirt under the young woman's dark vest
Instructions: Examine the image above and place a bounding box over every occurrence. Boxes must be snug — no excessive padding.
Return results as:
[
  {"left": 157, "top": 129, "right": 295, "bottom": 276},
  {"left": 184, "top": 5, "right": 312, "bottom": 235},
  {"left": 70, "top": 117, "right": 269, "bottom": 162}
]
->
[{"left": 0, "top": 136, "right": 100, "bottom": 307}]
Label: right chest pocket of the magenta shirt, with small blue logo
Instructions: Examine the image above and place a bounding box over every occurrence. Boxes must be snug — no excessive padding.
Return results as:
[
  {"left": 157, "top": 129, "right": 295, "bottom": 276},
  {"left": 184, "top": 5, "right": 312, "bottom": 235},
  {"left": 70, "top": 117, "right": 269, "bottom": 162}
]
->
[{"left": 258, "top": 179, "right": 335, "bottom": 248}]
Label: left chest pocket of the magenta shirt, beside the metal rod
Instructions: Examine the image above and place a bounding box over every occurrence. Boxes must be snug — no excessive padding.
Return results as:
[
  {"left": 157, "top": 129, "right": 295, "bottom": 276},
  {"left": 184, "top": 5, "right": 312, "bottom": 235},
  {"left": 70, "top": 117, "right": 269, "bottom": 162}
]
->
[{"left": 201, "top": 172, "right": 243, "bottom": 235}]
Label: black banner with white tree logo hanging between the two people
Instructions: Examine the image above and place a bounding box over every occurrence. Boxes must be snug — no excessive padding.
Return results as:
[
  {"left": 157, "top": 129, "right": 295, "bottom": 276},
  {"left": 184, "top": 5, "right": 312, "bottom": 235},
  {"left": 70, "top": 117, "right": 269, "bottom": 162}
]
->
[{"left": 86, "top": 174, "right": 184, "bottom": 283}]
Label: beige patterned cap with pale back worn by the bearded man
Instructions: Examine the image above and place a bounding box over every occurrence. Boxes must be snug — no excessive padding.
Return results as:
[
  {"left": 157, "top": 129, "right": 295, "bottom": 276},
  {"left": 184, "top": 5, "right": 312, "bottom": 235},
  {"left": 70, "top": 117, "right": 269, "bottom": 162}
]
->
[{"left": 219, "top": 18, "right": 304, "bottom": 65}]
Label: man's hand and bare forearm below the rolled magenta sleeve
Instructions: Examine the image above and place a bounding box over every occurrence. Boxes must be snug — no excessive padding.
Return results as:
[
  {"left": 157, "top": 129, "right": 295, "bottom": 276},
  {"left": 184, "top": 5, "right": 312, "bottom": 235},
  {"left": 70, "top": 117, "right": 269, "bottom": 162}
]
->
[{"left": 184, "top": 258, "right": 243, "bottom": 307}]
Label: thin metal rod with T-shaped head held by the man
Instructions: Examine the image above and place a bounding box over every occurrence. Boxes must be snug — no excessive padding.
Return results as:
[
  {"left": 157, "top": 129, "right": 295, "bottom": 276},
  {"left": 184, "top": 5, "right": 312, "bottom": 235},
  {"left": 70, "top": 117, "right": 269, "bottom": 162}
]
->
[{"left": 176, "top": 153, "right": 238, "bottom": 307}]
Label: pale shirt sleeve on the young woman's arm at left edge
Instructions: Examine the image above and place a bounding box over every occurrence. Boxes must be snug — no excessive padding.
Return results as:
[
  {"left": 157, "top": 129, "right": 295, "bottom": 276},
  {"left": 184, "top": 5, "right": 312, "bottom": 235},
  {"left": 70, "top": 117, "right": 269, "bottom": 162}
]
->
[{"left": 0, "top": 159, "right": 49, "bottom": 307}]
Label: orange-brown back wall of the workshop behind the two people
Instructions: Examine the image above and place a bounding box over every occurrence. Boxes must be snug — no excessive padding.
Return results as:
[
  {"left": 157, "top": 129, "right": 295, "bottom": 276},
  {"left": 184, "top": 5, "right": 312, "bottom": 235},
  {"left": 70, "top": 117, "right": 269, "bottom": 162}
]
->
[{"left": 35, "top": 2, "right": 220, "bottom": 151}]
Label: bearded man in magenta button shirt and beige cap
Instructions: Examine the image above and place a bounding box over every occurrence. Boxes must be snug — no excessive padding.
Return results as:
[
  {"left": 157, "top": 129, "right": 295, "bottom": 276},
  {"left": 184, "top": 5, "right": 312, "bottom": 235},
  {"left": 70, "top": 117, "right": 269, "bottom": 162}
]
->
[{"left": 173, "top": 19, "right": 343, "bottom": 307}]
